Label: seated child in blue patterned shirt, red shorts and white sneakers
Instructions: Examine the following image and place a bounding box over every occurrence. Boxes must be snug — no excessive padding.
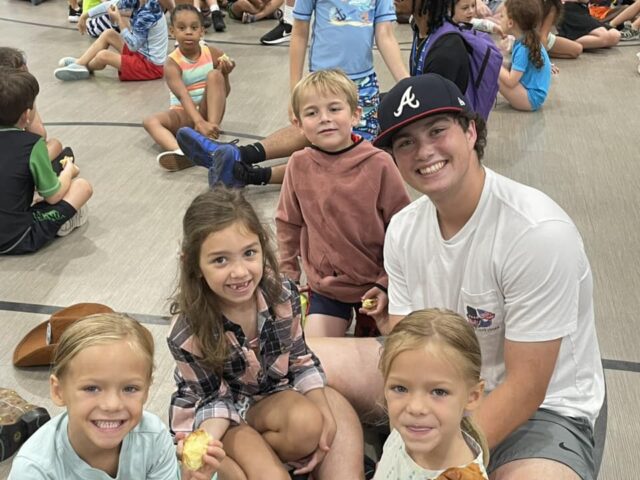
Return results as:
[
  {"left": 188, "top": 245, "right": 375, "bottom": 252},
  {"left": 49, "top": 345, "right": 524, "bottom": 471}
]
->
[{"left": 54, "top": 0, "right": 169, "bottom": 82}]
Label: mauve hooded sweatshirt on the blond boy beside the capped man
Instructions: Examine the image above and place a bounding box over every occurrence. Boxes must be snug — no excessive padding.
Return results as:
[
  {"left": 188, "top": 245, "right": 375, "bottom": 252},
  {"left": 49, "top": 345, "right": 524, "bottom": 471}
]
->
[{"left": 276, "top": 137, "right": 410, "bottom": 303}]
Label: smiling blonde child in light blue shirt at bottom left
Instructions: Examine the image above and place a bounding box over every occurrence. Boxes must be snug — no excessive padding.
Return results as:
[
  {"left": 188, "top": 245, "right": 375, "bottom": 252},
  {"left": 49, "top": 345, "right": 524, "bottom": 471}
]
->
[{"left": 9, "top": 313, "right": 224, "bottom": 480}]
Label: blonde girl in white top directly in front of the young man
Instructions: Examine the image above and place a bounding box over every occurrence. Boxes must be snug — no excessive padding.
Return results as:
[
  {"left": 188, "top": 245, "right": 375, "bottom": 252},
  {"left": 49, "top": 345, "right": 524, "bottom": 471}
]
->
[{"left": 373, "top": 309, "right": 489, "bottom": 480}]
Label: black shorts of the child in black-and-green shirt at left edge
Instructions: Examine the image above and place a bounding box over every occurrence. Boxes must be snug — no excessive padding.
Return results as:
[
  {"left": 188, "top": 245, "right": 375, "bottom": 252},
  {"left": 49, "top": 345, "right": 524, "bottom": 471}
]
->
[{"left": 0, "top": 200, "right": 76, "bottom": 255}]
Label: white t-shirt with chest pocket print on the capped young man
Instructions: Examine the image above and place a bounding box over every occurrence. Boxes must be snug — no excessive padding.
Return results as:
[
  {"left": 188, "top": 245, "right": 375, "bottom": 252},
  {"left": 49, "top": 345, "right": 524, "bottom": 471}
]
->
[{"left": 384, "top": 167, "right": 604, "bottom": 424}]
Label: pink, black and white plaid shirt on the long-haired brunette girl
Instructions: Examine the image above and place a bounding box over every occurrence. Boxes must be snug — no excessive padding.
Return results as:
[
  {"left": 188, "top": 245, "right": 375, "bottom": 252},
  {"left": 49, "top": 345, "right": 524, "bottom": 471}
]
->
[{"left": 167, "top": 280, "right": 326, "bottom": 434}]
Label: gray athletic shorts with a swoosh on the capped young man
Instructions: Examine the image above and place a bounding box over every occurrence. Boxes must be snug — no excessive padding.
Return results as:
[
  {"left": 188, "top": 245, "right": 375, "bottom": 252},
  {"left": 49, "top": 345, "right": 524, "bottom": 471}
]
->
[{"left": 487, "top": 408, "right": 596, "bottom": 480}]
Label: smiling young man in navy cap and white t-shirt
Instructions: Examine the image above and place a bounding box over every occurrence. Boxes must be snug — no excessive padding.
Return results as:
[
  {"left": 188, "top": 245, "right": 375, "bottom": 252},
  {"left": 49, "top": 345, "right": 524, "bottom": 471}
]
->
[{"left": 310, "top": 74, "right": 604, "bottom": 480}]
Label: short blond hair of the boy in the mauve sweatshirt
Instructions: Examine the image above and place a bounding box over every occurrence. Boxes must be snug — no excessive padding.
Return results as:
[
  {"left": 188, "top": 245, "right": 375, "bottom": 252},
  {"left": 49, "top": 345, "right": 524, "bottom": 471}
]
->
[{"left": 291, "top": 69, "right": 358, "bottom": 120}]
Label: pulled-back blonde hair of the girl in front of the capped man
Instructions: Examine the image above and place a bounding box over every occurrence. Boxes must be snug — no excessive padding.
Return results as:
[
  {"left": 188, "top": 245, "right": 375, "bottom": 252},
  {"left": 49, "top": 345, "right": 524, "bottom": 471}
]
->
[{"left": 379, "top": 308, "right": 489, "bottom": 465}]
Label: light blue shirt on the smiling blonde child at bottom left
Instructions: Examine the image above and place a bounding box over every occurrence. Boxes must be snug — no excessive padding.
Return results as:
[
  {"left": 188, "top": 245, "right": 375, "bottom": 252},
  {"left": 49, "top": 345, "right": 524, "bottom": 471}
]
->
[{"left": 9, "top": 412, "right": 180, "bottom": 480}]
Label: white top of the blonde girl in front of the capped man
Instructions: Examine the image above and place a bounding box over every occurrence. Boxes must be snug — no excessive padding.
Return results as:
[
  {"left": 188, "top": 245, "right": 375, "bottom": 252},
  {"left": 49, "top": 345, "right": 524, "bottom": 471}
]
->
[{"left": 373, "top": 429, "right": 488, "bottom": 480}]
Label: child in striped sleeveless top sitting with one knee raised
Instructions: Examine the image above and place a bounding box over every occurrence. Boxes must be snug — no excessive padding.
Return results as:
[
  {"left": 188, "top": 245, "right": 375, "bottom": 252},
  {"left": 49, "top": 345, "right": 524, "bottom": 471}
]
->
[{"left": 143, "top": 4, "right": 235, "bottom": 171}]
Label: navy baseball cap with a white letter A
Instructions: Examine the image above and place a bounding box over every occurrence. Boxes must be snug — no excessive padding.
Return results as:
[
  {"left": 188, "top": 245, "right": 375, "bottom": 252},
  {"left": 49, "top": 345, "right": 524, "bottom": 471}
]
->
[{"left": 373, "top": 73, "right": 471, "bottom": 147}]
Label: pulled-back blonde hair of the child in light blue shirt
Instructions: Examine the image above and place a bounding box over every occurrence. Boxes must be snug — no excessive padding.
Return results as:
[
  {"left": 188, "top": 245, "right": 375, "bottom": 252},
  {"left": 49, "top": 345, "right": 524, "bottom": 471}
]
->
[{"left": 51, "top": 313, "right": 154, "bottom": 380}]
